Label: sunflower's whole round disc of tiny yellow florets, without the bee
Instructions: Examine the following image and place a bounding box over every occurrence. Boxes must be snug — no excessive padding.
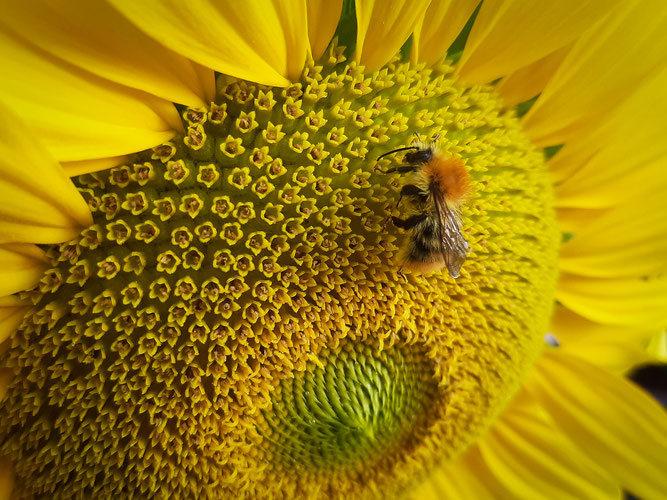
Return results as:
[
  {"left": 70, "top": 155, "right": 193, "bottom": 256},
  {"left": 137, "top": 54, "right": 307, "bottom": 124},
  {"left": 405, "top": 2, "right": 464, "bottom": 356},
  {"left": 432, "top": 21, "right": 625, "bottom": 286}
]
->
[{"left": 0, "top": 41, "right": 558, "bottom": 498}]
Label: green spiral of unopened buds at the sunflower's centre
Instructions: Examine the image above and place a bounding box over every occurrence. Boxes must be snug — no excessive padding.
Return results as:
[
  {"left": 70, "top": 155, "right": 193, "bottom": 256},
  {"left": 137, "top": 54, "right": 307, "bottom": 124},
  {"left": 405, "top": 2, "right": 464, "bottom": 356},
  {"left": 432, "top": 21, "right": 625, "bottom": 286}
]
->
[{"left": 264, "top": 344, "right": 437, "bottom": 469}]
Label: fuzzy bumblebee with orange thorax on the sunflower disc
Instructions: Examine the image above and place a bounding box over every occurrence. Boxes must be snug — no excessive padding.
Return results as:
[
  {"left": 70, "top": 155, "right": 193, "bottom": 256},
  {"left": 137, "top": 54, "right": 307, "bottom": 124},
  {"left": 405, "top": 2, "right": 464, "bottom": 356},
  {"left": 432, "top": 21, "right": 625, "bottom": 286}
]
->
[{"left": 378, "top": 136, "right": 470, "bottom": 278}]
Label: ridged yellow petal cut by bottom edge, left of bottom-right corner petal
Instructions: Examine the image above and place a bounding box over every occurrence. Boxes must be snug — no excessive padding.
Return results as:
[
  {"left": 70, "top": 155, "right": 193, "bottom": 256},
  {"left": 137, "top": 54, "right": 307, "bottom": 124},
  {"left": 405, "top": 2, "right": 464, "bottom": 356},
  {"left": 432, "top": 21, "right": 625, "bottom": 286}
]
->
[{"left": 479, "top": 410, "right": 622, "bottom": 500}]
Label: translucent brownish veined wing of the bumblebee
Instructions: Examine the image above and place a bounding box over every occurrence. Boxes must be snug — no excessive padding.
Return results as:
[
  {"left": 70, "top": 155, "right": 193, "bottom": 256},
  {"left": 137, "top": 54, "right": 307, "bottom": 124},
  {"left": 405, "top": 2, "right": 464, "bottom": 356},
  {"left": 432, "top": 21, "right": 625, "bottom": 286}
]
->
[{"left": 431, "top": 185, "right": 468, "bottom": 278}]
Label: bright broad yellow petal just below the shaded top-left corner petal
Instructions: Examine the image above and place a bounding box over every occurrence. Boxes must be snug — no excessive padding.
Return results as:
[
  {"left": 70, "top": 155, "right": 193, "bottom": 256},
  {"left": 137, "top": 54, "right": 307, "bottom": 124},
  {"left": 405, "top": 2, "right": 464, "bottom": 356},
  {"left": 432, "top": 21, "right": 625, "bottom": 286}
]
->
[{"left": 0, "top": 30, "right": 180, "bottom": 161}]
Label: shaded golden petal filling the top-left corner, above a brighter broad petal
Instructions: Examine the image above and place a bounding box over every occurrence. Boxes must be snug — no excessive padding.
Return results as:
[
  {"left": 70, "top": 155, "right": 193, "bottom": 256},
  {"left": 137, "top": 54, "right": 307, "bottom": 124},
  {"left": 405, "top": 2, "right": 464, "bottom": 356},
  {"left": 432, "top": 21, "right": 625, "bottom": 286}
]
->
[{"left": 0, "top": 0, "right": 215, "bottom": 106}]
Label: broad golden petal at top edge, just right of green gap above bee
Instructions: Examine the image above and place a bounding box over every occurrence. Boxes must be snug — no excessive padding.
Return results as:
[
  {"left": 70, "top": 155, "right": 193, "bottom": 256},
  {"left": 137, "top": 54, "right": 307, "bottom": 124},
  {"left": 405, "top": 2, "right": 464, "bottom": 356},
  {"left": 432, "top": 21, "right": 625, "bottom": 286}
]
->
[{"left": 459, "top": 0, "right": 620, "bottom": 83}]
